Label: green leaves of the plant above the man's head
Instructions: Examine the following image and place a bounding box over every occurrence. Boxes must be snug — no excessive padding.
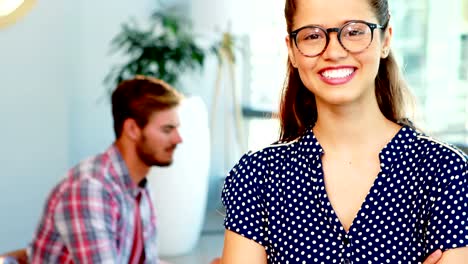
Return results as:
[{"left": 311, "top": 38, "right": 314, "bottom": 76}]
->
[{"left": 108, "top": 10, "right": 206, "bottom": 93}]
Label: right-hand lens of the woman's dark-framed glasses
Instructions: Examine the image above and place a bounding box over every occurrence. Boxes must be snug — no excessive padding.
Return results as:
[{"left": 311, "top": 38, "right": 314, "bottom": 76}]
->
[{"left": 340, "top": 22, "right": 372, "bottom": 52}]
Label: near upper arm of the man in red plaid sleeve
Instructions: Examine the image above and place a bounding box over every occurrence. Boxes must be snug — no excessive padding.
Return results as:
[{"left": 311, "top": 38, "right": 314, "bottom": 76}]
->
[{"left": 54, "top": 179, "right": 123, "bottom": 263}]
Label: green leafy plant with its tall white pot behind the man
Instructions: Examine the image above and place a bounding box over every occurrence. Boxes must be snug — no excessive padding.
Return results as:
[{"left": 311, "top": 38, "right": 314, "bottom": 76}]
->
[{"left": 105, "top": 9, "right": 210, "bottom": 256}]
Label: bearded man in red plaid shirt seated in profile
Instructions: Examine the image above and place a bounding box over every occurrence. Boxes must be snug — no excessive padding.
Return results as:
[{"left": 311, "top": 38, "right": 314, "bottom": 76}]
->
[{"left": 28, "top": 76, "right": 182, "bottom": 264}]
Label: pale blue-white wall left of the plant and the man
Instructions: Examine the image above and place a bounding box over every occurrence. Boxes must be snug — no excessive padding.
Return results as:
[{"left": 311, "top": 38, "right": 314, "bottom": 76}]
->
[{"left": 0, "top": 0, "right": 155, "bottom": 252}]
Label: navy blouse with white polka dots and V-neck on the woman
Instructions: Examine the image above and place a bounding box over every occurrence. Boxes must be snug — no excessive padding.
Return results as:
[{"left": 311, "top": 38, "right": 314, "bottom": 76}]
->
[{"left": 222, "top": 126, "right": 468, "bottom": 264}]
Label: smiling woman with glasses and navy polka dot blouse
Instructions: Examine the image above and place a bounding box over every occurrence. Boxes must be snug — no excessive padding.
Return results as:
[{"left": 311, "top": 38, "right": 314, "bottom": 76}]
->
[{"left": 222, "top": 0, "right": 468, "bottom": 264}]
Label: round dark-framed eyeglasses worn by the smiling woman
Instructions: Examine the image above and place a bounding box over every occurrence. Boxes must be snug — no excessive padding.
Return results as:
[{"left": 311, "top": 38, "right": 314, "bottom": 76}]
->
[{"left": 290, "top": 20, "right": 385, "bottom": 57}]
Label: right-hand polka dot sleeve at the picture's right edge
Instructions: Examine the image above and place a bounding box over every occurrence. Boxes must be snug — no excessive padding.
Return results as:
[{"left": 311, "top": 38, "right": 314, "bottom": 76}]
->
[{"left": 425, "top": 155, "right": 468, "bottom": 255}]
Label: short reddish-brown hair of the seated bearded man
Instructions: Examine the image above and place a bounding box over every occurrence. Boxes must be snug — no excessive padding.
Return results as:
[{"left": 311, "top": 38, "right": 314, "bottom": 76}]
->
[{"left": 112, "top": 75, "right": 182, "bottom": 138}]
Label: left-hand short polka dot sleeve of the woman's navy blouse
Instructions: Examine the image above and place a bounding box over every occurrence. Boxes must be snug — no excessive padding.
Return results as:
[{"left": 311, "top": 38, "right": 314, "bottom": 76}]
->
[{"left": 221, "top": 153, "right": 267, "bottom": 246}]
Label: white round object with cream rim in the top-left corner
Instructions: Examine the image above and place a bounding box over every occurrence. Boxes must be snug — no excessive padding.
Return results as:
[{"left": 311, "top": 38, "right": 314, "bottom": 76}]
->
[{"left": 0, "top": 0, "right": 36, "bottom": 28}]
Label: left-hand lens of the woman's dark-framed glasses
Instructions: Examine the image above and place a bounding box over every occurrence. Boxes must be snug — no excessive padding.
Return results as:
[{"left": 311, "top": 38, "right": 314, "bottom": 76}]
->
[{"left": 296, "top": 27, "right": 327, "bottom": 57}]
